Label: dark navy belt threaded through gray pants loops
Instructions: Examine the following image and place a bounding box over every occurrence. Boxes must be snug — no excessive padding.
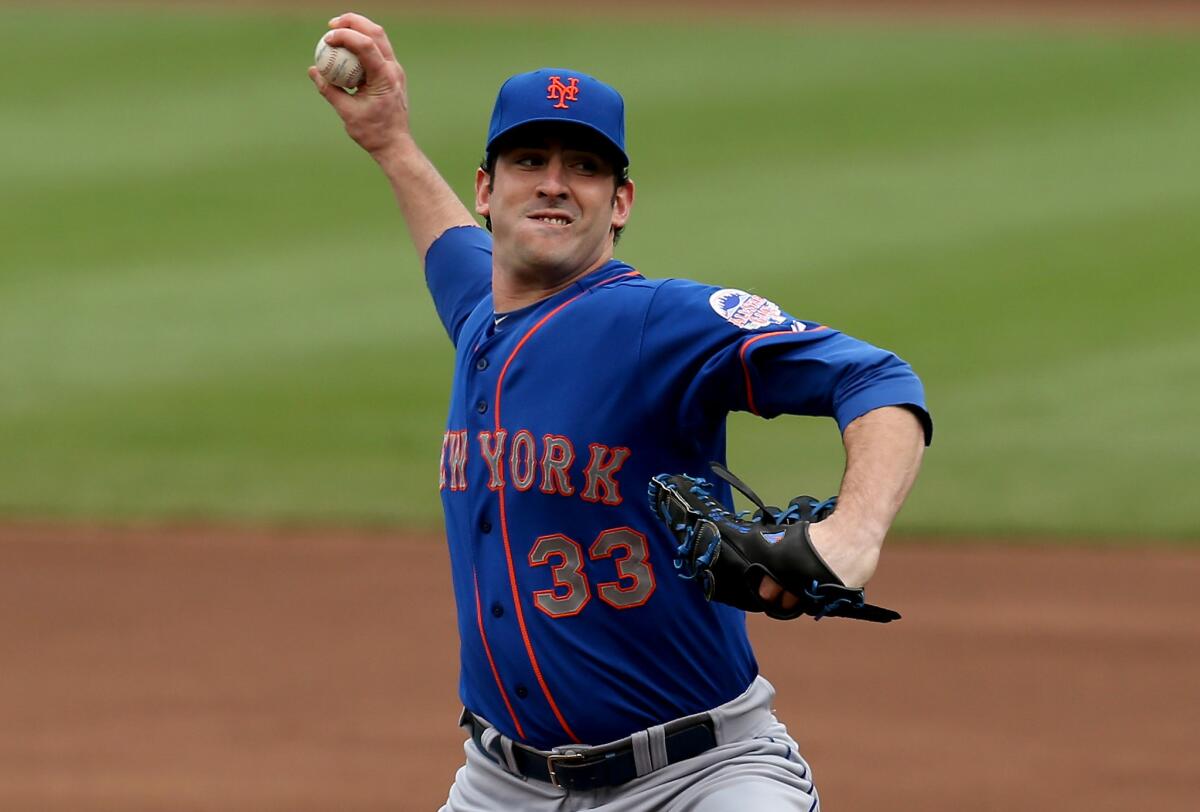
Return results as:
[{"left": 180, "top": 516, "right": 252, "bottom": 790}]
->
[{"left": 460, "top": 709, "right": 716, "bottom": 789}]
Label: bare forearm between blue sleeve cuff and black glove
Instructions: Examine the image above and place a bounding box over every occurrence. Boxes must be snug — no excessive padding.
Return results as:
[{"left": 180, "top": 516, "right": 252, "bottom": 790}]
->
[{"left": 810, "top": 407, "right": 925, "bottom": 587}]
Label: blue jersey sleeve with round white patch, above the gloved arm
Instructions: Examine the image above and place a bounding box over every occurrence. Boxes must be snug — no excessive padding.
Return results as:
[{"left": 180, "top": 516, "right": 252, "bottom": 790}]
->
[{"left": 640, "top": 279, "right": 932, "bottom": 443}]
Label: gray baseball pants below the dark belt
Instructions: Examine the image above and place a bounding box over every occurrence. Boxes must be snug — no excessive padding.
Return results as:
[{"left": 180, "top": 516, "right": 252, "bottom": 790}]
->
[{"left": 440, "top": 676, "right": 821, "bottom": 812}]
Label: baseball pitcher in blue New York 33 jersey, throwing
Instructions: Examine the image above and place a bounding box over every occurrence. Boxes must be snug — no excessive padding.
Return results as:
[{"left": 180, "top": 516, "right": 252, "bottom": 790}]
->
[{"left": 310, "top": 13, "right": 932, "bottom": 812}]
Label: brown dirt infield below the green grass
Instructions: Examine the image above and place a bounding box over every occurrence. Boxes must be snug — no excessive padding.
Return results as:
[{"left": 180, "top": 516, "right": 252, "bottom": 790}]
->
[{"left": 0, "top": 527, "right": 1200, "bottom": 812}]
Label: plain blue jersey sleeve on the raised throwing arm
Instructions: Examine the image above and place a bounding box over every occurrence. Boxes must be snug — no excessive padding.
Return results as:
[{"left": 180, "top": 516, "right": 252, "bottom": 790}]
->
[{"left": 425, "top": 225, "right": 492, "bottom": 347}]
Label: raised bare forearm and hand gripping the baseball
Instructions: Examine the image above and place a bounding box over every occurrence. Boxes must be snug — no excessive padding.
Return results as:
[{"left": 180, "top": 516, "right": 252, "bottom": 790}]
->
[{"left": 308, "top": 13, "right": 479, "bottom": 259}]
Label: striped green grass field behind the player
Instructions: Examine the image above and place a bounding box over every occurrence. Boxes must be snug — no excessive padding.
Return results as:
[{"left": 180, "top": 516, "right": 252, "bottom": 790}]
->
[{"left": 0, "top": 7, "right": 1200, "bottom": 540}]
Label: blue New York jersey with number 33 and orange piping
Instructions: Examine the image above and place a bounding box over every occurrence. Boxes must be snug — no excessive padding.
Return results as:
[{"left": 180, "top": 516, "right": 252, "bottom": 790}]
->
[{"left": 426, "top": 227, "right": 931, "bottom": 748}]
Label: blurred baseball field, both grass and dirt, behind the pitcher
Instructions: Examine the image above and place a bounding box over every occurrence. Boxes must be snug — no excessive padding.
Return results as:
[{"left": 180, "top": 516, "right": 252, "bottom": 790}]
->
[{"left": 0, "top": 0, "right": 1200, "bottom": 812}]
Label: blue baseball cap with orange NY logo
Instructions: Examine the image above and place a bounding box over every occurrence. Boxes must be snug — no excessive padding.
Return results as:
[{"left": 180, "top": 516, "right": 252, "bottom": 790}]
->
[{"left": 487, "top": 67, "right": 629, "bottom": 167}]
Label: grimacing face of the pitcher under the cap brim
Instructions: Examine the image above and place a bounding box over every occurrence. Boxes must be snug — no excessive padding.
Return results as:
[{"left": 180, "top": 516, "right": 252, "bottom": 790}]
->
[{"left": 475, "top": 131, "right": 634, "bottom": 284}]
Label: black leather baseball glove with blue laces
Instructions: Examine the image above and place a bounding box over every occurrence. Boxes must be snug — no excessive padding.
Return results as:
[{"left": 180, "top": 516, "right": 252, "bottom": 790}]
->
[{"left": 649, "top": 463, "right": 900, "bottom": 622}]
